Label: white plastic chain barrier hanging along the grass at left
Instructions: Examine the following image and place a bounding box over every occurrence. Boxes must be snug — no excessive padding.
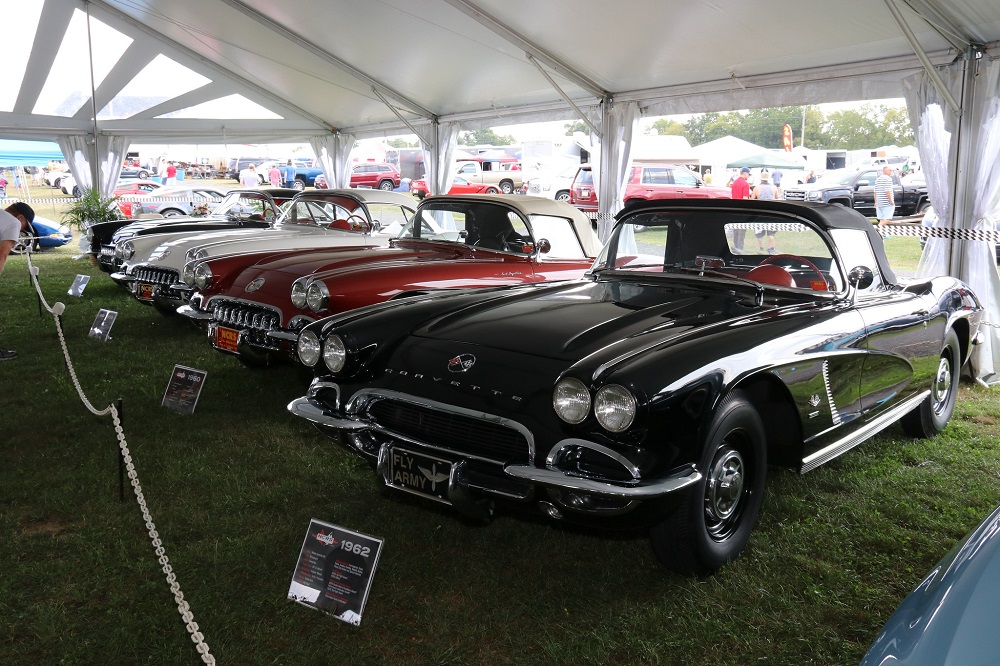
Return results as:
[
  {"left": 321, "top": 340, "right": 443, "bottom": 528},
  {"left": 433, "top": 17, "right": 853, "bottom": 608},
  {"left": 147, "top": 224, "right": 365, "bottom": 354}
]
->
[{"left": 25, "top": 251, "right": 215, "bottom": 664}]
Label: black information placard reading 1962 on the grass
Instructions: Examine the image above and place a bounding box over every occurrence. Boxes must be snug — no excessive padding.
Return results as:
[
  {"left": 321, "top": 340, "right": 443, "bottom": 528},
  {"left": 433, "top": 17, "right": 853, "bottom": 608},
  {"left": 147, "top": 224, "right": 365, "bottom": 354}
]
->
[{"left": 288, "top": 518, "right": 382, "bottom": 626}]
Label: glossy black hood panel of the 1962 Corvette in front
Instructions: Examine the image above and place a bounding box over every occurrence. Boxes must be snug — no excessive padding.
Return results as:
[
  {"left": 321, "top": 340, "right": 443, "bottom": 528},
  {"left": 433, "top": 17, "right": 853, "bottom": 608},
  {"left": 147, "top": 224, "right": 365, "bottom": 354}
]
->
[{"left": 413, "top": 280, "right": 788, "bottom": 361}]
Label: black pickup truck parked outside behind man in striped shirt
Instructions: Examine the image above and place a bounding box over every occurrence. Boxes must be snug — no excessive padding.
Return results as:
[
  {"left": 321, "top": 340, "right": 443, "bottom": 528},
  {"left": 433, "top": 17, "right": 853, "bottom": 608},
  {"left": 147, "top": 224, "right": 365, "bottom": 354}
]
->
[{"left": 782, "top": 168, "right": 930, "bottom": 217}]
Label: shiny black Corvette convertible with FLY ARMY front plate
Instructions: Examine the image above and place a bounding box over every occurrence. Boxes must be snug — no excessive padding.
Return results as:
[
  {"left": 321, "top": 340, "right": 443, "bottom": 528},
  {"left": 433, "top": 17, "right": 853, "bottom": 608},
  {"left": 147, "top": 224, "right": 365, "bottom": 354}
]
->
[{"left": 289, "top": 200, "right": 982, "bottom": 575}]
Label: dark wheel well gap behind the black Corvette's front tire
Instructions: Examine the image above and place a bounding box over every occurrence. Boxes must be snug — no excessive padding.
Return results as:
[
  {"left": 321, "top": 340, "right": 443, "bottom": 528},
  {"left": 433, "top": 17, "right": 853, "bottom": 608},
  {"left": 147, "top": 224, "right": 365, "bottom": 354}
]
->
[{"left": 730, "top": 374, "right": 802, "bottom": 469}]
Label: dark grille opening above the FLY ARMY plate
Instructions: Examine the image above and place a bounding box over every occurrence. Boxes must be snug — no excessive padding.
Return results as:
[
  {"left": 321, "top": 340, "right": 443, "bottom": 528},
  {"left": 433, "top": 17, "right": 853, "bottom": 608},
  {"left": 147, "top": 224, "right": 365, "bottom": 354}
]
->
[{"left": 367, "top": 398, "right": 530, "bottom": 463}]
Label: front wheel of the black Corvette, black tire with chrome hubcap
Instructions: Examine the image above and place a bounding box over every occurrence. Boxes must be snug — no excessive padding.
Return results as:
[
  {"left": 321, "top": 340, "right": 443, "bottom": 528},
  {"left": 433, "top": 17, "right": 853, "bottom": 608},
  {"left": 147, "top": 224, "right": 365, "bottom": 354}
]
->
[{"left": 650, "top": 391, "right": 767, "bottom": 576}]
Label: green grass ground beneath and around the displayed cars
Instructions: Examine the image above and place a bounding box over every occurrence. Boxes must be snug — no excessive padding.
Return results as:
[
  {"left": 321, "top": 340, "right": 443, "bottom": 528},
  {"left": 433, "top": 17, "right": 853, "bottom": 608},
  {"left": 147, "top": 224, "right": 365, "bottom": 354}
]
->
[{"left": 0, "top": 197, "right": 1000, "bottom": 666}]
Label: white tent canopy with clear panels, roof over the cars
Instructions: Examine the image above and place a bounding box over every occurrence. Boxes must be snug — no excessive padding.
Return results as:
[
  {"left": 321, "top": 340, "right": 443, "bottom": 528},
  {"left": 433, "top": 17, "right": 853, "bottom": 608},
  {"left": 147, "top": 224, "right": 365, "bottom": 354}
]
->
[{"left": 0, "top": 0, "right": 1000, "bottom": 378}]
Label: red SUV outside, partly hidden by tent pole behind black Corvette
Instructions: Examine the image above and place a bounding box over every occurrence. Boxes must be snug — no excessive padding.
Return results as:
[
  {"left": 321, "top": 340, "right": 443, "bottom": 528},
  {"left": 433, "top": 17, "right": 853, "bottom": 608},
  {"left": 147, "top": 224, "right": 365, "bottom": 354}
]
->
[{"left": 569, "top": 164, "right": 732, "bottom": 218}]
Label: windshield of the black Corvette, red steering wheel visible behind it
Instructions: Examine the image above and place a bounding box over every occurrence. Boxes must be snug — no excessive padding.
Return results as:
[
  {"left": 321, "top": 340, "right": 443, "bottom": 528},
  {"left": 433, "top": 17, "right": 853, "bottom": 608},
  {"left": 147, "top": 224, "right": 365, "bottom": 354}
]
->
[{"left": 592, "top": 210, "right": 845, "bottom": 292}]
